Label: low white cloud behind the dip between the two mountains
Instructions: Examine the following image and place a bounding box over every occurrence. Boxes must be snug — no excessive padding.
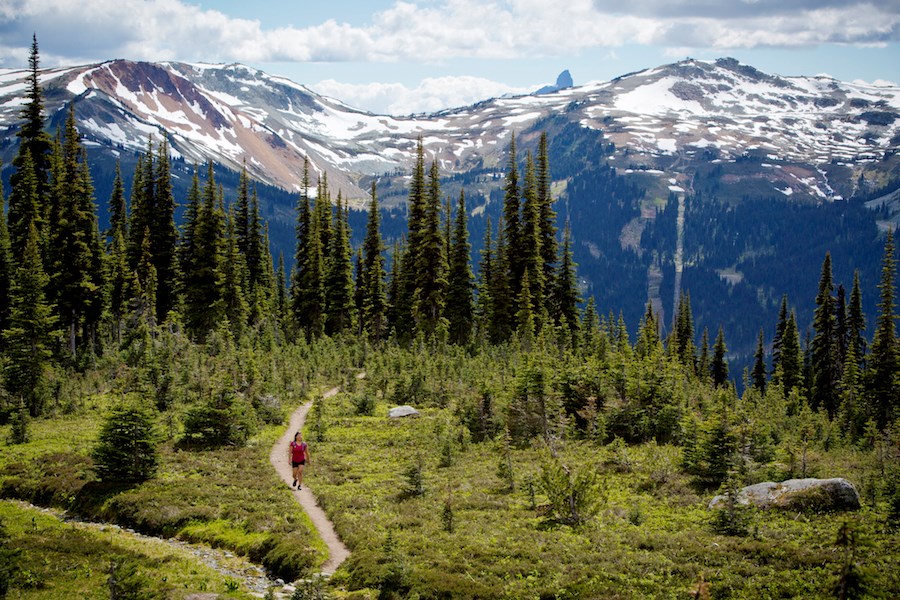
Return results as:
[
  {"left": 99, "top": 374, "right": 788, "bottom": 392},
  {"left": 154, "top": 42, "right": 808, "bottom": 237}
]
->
[{"left": 310, "top": 77, "right": 540, "bottom": 115}]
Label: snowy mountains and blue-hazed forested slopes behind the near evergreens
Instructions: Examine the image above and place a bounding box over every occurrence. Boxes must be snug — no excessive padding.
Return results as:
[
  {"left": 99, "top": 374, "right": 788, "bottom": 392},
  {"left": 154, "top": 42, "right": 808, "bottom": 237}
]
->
[{"left": 0, "top": 59, "right": 900, "bottom": 368}]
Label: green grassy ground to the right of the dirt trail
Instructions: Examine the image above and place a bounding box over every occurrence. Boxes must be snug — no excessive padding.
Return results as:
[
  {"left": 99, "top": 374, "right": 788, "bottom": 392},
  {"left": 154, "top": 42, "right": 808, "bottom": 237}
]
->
[{"left": 309, "top": 394, "right": 900, "bottom": 598}]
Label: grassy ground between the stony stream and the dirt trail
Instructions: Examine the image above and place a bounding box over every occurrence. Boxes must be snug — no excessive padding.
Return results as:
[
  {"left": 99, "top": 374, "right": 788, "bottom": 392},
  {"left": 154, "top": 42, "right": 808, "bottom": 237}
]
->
[{"left": 0, "top": 390, "right": 327, "bottom": 581}]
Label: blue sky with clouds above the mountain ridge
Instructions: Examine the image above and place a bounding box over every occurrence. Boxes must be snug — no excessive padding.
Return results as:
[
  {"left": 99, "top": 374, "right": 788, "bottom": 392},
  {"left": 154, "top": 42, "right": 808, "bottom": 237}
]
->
[{"left": 0, "top": 0, "right": 900, "bottom": 114}]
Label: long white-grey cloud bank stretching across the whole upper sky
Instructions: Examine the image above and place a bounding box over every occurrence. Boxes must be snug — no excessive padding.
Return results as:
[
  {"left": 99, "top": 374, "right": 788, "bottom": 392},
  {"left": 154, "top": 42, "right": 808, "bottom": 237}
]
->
[{"left": 0, "top": 0, "right": 900, "bottom": 65}]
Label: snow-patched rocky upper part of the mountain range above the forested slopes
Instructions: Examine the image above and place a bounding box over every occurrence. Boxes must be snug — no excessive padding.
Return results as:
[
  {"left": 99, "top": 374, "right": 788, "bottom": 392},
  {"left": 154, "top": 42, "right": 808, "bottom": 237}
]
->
[{"left": 0, "top": 59, "right": 900, "bottom": 205}]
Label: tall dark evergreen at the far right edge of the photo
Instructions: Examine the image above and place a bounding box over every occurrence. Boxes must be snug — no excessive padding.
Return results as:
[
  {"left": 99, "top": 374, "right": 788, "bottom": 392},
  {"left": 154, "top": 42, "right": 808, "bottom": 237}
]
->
[{"left": 866, "top": 230, "right": 900, "bottom": 429}]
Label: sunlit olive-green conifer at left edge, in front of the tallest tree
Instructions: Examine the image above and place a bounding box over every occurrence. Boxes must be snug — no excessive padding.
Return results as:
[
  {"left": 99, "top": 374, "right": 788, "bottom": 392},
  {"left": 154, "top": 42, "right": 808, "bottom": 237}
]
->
[{"left": 2, "top": 223, "right": 56, "bottom": 417}]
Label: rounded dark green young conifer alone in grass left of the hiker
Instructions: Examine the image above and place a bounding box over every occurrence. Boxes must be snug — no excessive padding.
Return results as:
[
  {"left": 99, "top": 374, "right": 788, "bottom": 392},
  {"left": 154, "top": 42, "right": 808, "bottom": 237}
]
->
[{"left": 92, "top": 403, "right": 159, "bottom": 481}]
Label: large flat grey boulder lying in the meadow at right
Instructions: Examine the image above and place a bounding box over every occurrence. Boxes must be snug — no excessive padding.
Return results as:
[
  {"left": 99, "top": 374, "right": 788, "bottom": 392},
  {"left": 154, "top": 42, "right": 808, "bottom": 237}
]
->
[{"left": 709, "top": 477, "right": 860, "bottom": 512}]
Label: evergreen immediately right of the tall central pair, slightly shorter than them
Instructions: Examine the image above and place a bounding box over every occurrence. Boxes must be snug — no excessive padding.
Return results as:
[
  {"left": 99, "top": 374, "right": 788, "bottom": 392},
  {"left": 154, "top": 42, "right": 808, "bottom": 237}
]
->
[{"left": 447, "top": 191, "right": 475, "bottom": 345}]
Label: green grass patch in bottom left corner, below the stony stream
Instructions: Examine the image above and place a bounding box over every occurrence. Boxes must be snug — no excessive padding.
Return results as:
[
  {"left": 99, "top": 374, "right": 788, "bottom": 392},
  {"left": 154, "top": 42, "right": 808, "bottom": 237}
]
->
[{"left": 0, "top": 501, "right": 252, "bottom": 600}]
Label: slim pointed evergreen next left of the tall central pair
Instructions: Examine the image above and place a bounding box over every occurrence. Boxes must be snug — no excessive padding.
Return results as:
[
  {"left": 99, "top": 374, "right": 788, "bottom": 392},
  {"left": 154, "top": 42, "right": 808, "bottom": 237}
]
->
[{"left": 357, "top": 181, "right": 387, "bottom": 340}]
